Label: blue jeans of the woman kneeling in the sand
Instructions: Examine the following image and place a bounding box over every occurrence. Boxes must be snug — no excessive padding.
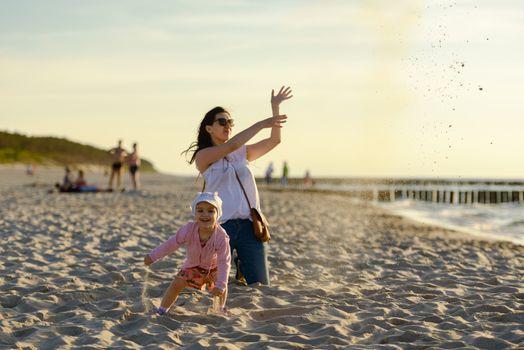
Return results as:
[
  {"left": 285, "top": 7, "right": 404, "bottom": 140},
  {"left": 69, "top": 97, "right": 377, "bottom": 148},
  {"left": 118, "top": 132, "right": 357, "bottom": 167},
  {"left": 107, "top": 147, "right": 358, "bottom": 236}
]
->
[{"left": 221, "top": 219, "right": 269, "bottom": 285}]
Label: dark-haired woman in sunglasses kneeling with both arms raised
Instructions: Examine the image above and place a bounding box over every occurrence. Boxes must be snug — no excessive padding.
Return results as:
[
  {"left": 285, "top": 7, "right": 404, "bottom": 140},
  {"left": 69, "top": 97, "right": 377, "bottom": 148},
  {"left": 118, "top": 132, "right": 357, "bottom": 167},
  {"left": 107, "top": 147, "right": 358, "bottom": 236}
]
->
[{"left": 185, "top": 86, "right": 292, "bottom": 285}]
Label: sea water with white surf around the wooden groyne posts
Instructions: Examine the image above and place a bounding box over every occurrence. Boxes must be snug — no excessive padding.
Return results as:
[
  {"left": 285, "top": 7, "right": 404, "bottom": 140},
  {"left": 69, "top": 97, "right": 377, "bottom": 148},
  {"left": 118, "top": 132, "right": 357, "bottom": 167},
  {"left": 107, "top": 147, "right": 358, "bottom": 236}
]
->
[{"left": 315, "top": 179, "right": 524, "bottom": 245}]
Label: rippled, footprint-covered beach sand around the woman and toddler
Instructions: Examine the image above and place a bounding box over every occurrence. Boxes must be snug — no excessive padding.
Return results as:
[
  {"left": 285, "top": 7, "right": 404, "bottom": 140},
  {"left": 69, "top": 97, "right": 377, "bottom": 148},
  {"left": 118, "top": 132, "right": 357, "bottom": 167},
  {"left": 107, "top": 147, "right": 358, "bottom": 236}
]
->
[{"left": 0, "top": 167, "right": 524, "bottom": 349}]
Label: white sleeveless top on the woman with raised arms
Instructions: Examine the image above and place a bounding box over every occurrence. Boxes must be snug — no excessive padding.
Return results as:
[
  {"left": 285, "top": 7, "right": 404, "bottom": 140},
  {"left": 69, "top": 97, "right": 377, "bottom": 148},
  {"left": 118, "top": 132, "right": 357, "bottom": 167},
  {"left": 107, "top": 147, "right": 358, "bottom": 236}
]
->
[{"left": 202, "top": 145, "right": 260, "bottom": 223}]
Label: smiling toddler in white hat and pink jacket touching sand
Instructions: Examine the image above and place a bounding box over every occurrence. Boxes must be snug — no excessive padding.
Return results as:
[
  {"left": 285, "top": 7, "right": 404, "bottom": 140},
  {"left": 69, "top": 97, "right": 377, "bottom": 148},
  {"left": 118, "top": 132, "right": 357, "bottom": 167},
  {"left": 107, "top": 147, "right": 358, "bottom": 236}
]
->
[{"left": 144, "top": 192, "right": 231, "bottom": 315}]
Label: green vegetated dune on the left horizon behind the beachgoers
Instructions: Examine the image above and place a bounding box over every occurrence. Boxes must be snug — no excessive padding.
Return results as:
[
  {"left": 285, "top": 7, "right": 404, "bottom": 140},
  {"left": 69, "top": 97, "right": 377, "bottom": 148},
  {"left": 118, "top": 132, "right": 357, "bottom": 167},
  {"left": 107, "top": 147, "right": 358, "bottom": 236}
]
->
[{"left": 0, "top": 131, "right": 156, "bottom": 172}]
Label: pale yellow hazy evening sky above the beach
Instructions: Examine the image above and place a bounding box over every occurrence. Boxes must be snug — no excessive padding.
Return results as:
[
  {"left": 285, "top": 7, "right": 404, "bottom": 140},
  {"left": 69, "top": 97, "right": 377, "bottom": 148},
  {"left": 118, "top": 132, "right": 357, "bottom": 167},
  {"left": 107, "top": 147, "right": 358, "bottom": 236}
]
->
[{"left": 0, "top": 0, "right": 524, "bottom": 179}]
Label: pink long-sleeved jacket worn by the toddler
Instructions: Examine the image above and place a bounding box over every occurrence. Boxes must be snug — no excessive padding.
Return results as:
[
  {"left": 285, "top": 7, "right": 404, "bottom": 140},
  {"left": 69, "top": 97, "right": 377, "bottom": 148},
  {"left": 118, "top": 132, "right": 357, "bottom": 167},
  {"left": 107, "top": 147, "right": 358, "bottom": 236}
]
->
[{"left": 149, "top": 221, "right": 231, "bottom": 290}]
